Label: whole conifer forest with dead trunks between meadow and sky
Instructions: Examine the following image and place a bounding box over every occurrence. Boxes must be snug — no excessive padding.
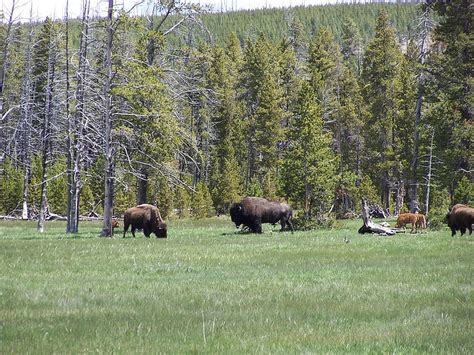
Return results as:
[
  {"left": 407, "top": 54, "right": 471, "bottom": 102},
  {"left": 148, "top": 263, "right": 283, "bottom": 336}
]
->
[{"left": 0, "top": 0, "right": 474, "bottom": 236}]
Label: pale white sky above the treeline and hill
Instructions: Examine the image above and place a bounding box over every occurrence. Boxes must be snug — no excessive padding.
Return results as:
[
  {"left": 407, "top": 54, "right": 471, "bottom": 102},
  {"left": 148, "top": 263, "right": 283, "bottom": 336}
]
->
[{"left": 1, "top": 0, "right": 341, "bottom": 21}]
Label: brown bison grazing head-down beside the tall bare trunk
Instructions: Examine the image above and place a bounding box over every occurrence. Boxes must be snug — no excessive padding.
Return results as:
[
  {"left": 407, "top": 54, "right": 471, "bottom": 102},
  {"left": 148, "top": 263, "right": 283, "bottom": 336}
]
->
[{"left": 123, "top": 204, "right": 167, "bottom": 238}]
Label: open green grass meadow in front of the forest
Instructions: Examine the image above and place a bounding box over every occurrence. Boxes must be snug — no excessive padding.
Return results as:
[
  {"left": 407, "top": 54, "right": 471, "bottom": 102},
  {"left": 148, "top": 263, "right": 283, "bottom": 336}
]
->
[{"left": 0, "top": 218, "right": 474, "bottom": 354}]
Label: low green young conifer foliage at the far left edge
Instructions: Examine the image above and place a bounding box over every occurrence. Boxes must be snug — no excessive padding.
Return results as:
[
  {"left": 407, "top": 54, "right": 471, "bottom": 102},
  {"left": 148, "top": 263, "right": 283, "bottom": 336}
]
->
[{"left": 0, "top": 159, "right": 23, "bottom": 214}]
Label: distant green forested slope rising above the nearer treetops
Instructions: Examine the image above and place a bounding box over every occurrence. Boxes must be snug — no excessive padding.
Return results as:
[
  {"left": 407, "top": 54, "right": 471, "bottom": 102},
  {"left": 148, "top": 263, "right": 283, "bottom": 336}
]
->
[{"left": 195, "top": 3, "right": 418, "bottom": 45}]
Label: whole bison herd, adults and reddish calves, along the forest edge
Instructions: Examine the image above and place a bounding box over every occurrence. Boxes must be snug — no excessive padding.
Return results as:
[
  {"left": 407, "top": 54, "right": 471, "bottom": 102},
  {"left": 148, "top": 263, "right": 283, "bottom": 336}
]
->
[{"left": 112, "top": 197, "right": 474, "bottom": 238}]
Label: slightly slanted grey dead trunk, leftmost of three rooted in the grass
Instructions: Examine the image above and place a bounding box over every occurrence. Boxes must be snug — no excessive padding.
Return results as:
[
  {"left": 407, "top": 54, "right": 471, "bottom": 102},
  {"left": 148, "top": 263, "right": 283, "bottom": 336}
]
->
[{"left": 37, "top": 29, "right": 56, "bottom": 233}]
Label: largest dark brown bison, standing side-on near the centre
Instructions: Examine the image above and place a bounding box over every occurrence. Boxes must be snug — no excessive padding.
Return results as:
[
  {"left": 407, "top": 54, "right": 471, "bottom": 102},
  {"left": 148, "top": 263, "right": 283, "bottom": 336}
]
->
[{"left": 230, "top": 197, "right": 293, "bottom": 233}]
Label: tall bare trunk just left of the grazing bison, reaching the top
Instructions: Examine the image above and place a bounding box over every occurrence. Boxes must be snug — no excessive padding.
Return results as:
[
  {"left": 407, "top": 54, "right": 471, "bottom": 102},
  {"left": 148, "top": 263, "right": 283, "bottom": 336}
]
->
[{"left": 102, "top": 0, "right": 115, "bottom": 237}]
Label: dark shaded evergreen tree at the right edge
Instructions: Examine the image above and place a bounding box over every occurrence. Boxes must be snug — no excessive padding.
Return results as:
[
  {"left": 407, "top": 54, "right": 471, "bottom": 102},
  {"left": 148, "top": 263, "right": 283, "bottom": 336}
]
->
[{"left": 428, "top": 0, "right": 474, "bottom": 195}]
